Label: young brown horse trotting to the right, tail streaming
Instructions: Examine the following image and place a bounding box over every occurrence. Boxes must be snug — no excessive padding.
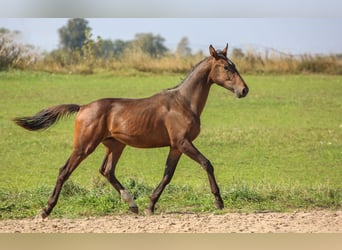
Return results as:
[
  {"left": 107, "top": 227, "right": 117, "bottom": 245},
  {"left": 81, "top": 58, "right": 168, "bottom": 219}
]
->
[{"left": 14, "top": 45, "right": 248, "bottom": 218}]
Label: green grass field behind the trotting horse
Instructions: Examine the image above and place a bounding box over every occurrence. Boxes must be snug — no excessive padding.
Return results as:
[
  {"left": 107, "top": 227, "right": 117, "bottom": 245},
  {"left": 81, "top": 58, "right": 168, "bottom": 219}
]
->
[{"left": 0, "top": 71, "right": 342, "bottom": 219}]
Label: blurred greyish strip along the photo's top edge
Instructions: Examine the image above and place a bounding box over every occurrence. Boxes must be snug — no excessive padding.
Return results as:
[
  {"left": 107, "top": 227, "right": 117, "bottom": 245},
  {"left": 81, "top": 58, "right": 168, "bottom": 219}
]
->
[{"left": 0, "top": 0, "right": 342, "bottom": 18}]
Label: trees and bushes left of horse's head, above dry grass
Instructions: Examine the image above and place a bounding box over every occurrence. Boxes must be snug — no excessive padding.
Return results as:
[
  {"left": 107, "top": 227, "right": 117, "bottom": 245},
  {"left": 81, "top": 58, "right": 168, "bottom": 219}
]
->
[{"left": 0, "top": 18, "right": 192, "bottom": 69}]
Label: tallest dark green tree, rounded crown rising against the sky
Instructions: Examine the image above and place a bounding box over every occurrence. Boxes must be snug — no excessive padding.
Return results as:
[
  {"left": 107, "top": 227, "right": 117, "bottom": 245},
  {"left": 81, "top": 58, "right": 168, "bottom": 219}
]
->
[{"left": 58, "top": 18, "right": 91, "bottom": 50}]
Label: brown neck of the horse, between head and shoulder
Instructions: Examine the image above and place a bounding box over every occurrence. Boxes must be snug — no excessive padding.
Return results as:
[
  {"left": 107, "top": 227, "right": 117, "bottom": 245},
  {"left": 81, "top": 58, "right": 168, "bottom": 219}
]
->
[{"left": 178, "top": 59, "right": 212, "bottom": 116}]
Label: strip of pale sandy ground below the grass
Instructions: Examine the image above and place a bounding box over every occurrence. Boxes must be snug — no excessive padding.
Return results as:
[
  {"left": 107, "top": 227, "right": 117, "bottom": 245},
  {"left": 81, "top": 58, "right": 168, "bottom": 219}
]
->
[{"left": 0, "top": 211, "right": 342, "bottom": 233}]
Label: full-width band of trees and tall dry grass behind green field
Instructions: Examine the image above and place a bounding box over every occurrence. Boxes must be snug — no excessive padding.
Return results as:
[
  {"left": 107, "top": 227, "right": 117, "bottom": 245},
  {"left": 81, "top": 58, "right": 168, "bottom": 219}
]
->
[{"left": 0, "top": 18, "right": 342, "bottom": 74}]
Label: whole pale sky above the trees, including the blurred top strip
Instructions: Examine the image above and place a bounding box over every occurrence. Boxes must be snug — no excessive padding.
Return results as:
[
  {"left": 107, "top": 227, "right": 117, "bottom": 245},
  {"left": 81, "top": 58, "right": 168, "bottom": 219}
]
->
[{"left": 0, "top": 0, "right": 342, "bottom": 55}]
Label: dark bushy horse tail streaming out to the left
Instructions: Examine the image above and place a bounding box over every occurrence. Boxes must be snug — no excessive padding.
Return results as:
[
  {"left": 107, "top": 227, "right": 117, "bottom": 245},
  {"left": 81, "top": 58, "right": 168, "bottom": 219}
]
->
[{"left": 13, "top": 104, "right": 81, "bottom": 131}]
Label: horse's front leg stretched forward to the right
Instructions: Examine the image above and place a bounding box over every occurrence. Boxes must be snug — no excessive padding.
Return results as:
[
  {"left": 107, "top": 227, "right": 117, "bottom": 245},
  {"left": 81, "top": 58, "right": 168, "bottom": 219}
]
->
[{"left": 178, "top": 139, "right": 224, "bottom": 209}]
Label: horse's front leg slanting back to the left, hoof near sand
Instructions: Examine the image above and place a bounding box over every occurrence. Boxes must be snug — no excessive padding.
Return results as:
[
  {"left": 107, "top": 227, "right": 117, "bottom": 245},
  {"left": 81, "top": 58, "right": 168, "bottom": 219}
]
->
[{"left": 146, "top": 147, "right": 182, "bottom": 215}]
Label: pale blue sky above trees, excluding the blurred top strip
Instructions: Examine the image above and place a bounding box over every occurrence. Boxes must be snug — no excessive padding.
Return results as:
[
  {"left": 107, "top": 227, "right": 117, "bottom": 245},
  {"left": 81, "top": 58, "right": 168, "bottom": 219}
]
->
[{"left": 0, "top": 18, "right": 342, "bottom": 55}]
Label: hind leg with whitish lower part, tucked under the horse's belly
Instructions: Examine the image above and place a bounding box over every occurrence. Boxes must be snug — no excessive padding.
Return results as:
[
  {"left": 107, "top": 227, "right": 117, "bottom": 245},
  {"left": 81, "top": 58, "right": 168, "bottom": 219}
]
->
[{"left": 100, "top": 138, "right": 139, "bottom": 213}]
